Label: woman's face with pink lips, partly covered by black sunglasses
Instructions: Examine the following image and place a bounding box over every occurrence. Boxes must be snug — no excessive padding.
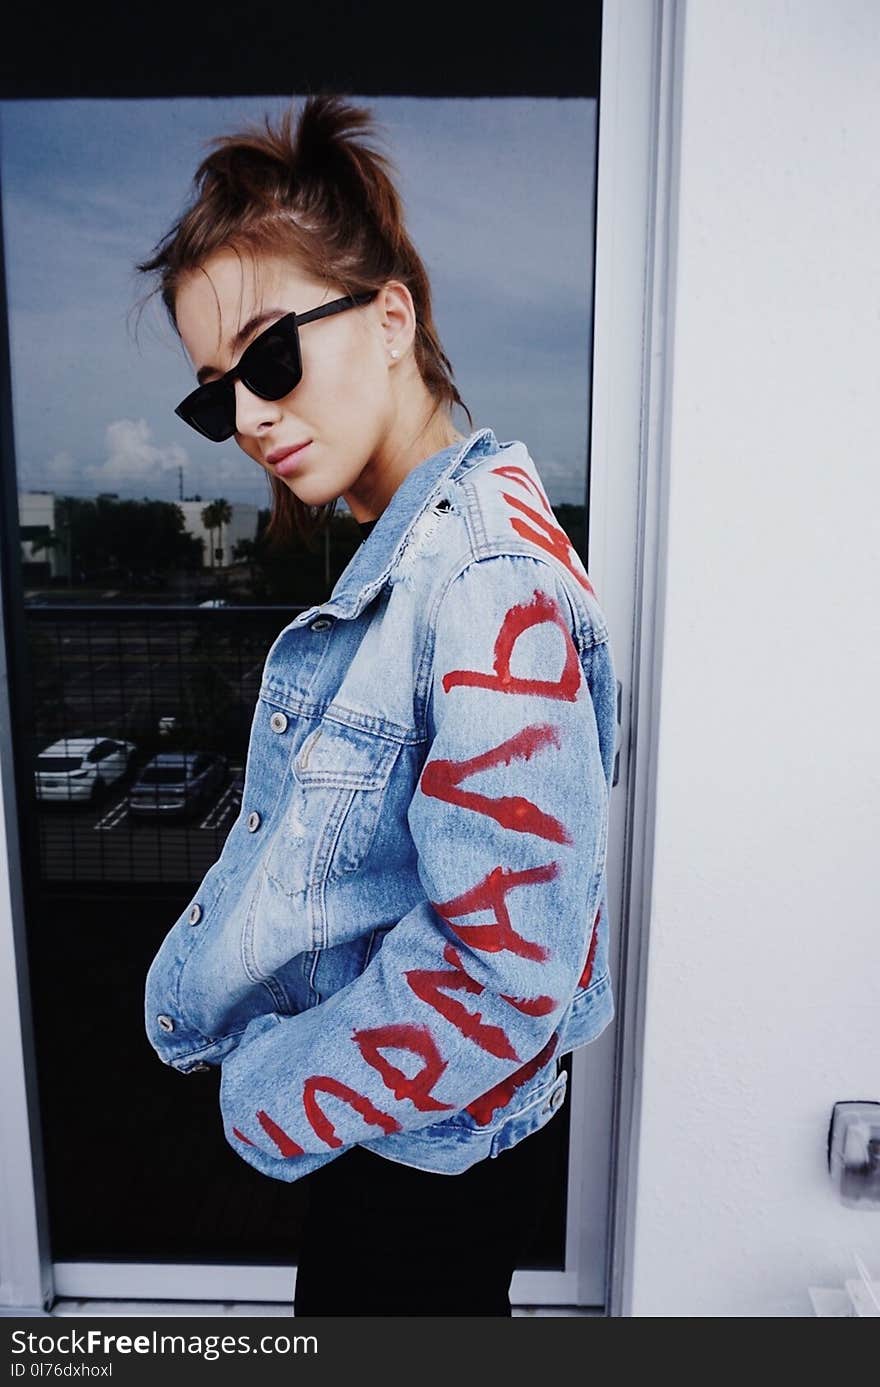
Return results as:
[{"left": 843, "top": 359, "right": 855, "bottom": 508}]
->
[{"left": 175, "top": 250, "right": 412, "bottom": 506}]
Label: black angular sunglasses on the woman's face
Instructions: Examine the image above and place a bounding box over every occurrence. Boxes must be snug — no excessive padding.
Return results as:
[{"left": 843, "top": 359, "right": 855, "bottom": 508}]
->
[{"left": 175, "top": 290, "right": 379, "bottom": 442}]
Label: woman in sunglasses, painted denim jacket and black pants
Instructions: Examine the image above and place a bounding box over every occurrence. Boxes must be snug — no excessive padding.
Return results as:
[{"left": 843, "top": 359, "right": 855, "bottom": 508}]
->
[{"left": 139, "top": 96, "right": 616, "bottom": 1315}]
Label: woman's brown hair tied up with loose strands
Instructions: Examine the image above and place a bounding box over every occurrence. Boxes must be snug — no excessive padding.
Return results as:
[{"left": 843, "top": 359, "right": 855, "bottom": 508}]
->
[{"left": 135, "top": 93, "right": 473, "bottom": 544}]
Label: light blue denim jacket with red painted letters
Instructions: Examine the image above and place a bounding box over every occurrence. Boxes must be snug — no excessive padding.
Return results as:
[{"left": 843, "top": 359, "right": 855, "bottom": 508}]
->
[{"left": 146, "top": 429, "right": 616, "bottom": 1180}]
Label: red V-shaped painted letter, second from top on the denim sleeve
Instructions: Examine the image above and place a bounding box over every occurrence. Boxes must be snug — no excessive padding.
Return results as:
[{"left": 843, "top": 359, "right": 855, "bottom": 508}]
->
[{"left": 419, "top": 723, "right": 572, "bottom": 843}]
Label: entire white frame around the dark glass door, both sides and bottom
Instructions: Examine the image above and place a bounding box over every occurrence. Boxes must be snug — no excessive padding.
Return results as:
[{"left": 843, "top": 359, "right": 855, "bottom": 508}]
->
[{"left": 0, "top": 0, "right": 684, "bottom": 1316}]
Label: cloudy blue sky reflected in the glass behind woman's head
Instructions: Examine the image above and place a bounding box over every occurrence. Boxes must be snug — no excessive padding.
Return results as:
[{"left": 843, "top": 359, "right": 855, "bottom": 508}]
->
[{"left": 0, "top": 96, "right": 595, "bottom": 506}]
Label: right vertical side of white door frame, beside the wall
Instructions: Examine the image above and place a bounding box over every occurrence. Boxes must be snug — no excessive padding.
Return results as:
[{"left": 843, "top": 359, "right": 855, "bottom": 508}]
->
[{"left": 591, "top": 0, "right": 687, "bottom": 1318}]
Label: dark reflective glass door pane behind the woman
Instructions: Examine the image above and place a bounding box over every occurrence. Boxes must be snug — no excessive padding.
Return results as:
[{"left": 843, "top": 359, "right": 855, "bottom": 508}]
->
[{"left": 0, "top": 86, "right": 597, "bottom": 1266}]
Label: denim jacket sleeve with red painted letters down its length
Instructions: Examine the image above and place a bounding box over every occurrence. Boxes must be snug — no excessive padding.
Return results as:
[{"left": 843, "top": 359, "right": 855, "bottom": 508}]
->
[{"left": 221, "top": 552, "right": 609, "bottom": 1173}]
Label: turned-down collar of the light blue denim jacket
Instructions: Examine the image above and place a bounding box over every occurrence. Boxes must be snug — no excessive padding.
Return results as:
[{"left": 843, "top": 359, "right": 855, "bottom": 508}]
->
[{"left": 301, "top": 429, "right": 498, "bottom": 624}]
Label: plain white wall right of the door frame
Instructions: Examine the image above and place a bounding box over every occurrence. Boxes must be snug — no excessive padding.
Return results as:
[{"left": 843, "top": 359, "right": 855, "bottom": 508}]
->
[{"left": 632, "top": 0, "right": 880, "bottom": 1316}]
